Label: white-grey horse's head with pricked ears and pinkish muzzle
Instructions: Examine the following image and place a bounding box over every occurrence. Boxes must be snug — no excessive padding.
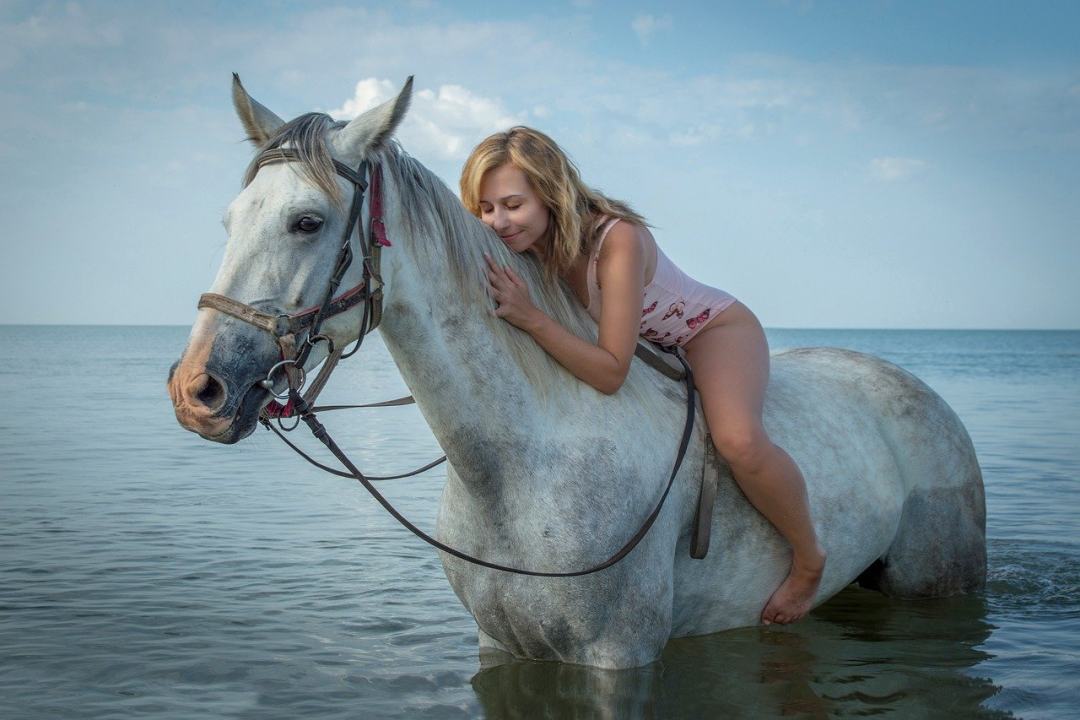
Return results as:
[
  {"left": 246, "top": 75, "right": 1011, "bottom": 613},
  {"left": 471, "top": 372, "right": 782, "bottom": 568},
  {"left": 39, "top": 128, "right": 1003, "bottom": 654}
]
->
[{"left": 168, "top": 76, "right": 411, "bottom": 443}]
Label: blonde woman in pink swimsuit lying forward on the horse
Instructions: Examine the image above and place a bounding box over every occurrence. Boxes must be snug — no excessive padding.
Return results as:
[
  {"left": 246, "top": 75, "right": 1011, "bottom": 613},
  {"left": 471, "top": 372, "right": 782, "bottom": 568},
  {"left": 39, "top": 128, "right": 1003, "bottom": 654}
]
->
[{"left": 461, "top": 126, "right": 825, "bottom": 624}]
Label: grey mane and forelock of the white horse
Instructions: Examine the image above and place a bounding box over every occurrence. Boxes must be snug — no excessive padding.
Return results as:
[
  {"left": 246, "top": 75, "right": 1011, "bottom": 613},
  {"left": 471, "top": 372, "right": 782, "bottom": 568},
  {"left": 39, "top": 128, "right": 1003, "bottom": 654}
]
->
[{"left": 244, "top": 112, "right": 657, "bottom": 405}]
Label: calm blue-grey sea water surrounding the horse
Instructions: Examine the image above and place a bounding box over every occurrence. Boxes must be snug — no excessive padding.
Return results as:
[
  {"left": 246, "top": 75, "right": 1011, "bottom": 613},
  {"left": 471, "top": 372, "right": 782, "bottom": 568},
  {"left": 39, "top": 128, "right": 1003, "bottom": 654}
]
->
[{"left": 0, "top": 326, "right": 1080, "bottom": 720}]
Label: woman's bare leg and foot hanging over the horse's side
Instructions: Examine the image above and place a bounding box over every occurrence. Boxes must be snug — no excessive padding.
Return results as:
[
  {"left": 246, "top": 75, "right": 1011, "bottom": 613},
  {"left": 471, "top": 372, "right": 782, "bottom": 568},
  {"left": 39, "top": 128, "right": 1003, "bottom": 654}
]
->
[{"left": 686, "top": 302, "right": 825, "bottom": 625}]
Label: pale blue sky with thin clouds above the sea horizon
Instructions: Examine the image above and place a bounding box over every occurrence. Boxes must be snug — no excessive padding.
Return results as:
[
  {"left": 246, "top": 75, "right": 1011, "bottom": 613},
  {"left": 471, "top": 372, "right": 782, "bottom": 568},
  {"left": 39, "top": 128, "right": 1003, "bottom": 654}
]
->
[{"left": 0, "top": 0, "right": 1080, "bottom": 328}]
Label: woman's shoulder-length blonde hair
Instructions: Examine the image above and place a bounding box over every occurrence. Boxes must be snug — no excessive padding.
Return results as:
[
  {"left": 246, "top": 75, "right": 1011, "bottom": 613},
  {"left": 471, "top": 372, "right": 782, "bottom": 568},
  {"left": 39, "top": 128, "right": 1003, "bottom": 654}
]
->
[{"left": 461, "top": 125, "right": 647, "bottom": 275}]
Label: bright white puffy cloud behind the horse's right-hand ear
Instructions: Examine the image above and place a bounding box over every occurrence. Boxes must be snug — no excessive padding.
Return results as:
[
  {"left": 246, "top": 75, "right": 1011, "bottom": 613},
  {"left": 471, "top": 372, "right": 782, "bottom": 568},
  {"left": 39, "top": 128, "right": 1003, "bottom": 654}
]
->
[{"left": 329, "top": 78, "right": 523, "bottom": 160}]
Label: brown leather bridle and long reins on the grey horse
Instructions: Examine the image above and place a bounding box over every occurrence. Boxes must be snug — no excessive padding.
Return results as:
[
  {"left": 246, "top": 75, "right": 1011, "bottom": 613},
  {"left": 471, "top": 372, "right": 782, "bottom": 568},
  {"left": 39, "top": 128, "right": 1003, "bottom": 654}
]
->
[{"left": 199, "top": 148, "right": 696, "bottom": 578}]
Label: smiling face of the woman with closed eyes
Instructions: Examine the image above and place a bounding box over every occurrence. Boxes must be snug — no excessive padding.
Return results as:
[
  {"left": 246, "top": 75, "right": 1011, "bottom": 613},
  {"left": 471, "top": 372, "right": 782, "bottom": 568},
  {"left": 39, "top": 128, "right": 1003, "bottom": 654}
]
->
[{"left": 480, "top": 163, "right": 551, "bottom": 255}]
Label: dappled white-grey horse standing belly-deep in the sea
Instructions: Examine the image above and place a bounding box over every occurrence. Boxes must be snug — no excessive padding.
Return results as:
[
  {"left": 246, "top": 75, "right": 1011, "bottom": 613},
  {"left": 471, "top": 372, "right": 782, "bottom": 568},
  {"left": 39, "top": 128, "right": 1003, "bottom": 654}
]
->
[{"left": 168, "top": 79, "right": 986, "bottom": 668}]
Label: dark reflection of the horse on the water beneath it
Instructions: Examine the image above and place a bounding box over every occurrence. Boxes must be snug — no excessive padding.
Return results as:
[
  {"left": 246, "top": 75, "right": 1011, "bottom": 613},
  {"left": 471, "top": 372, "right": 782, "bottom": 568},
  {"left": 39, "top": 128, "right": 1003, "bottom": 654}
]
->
[{"left": 472, "top": 587, "right": 1011, "bottom": 718}]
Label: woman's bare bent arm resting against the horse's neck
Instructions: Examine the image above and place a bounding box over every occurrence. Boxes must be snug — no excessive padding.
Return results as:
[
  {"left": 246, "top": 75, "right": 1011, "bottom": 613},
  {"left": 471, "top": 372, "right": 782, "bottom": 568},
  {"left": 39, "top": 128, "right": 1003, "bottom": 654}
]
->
[{"left": 488, "top": 222, "right": 645, "bottom": 395}]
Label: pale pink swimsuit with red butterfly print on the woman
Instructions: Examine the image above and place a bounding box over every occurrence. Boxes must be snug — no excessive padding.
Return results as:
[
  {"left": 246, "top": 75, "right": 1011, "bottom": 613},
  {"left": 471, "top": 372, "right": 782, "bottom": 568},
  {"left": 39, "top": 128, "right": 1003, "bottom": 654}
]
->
[{"left": 588, "top": 218, "right": 735, "bottom": 345}]
